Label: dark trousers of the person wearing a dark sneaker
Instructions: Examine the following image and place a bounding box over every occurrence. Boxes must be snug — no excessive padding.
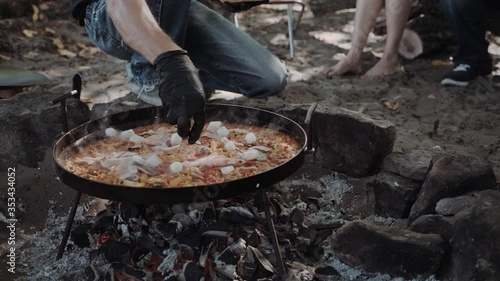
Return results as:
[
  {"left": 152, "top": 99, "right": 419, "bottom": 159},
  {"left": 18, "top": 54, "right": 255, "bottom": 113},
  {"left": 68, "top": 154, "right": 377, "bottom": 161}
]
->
[{"left": 441, "top": 0, "right": 500, "bottom": 72}]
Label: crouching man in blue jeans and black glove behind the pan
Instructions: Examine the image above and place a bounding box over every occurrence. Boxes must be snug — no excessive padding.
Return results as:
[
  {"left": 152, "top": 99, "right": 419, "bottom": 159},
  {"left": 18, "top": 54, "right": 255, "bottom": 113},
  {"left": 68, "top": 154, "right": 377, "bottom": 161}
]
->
[{"left": 72, "top": 0, "right": 289, "bottom": 143}]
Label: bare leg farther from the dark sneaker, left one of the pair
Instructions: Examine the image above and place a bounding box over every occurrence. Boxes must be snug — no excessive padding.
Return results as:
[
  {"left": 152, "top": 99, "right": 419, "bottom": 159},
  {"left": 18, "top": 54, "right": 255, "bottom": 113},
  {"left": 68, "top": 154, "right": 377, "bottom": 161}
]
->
[{"left": 327, "top": 0, "right": 384, "bottom": 76}]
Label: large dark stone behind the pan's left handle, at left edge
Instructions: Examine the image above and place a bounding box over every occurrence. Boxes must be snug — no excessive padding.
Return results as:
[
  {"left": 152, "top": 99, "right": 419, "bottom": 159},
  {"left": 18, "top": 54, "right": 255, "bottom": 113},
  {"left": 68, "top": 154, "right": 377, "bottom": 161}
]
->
[{"left": 0, "top": 91, "right": 90, "bottom": 170}]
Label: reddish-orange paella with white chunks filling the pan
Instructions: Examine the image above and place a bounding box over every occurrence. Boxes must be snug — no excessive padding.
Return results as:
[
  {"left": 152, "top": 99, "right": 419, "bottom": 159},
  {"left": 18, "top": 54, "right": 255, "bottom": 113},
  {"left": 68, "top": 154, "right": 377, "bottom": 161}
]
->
[{"left": 60, "top": 121, "right": 302, "bottom": 187}]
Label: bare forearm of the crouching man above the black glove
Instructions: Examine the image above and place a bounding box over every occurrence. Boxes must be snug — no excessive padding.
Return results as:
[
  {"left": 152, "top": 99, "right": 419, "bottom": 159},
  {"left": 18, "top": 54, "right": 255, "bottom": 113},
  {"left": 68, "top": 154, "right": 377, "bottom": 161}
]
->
[{"left": 106, "top": 0, "right": 181, "bottom": 63}]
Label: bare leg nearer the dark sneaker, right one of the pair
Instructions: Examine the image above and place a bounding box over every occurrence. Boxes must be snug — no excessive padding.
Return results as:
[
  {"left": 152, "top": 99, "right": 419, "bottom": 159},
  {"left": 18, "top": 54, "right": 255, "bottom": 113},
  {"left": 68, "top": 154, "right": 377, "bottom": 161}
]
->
[{"left": 364, "top": 0, "right": 411, "bottom": 78}]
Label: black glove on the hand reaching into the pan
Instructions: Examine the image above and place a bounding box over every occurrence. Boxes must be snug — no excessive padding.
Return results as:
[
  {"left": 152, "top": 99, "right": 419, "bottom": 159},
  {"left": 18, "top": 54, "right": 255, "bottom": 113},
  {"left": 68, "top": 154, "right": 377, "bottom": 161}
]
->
[{"left": 153, "top": 50, "right": 205, "bottom": 144}]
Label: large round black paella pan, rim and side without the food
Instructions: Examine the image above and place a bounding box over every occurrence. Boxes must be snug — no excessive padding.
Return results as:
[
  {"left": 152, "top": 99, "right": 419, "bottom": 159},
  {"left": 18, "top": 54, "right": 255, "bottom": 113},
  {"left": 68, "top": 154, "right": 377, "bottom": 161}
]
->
[{"left": 53, "top": 104, "right": 307, "bottom": 204}]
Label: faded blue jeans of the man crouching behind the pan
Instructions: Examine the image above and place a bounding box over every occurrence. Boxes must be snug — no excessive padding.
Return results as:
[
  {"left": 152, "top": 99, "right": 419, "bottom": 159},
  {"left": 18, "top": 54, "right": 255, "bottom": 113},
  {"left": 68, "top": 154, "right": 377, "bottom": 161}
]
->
[{"left": 85, "top": 0, "right": 289, "bottom": 98}]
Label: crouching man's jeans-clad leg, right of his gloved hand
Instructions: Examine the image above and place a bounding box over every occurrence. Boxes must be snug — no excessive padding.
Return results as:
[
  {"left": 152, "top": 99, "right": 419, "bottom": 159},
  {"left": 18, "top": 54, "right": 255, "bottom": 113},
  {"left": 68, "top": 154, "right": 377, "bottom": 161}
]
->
[{"left": 185, "top": 1, "right": 289, "bottom": 98}]
